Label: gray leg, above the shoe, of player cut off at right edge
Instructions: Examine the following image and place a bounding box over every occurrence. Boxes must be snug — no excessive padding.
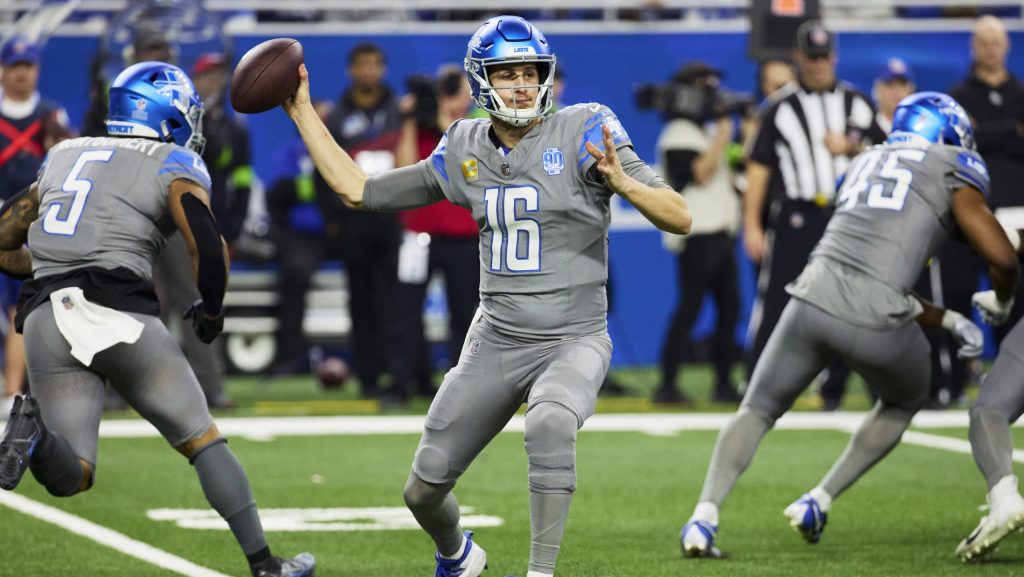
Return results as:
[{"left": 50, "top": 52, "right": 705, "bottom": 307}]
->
[{"left": 970, "top": 321, "right": 1024, "bottom": 489}]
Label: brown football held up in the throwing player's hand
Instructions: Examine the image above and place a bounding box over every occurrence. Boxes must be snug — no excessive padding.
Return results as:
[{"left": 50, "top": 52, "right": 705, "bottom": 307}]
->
[{"left": 231, "top": 38, "right": 302, "bottom": 114}]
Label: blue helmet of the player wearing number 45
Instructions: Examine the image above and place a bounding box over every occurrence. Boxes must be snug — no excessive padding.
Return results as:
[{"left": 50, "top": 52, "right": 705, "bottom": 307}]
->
[{"left": 886, "top": 92, "right": 975, "bottom": 151}]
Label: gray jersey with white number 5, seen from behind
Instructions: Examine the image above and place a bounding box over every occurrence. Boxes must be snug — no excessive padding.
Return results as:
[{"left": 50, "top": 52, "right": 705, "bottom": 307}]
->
[{"left": 29, "top": 137, "right": 210, "bottom": 280}]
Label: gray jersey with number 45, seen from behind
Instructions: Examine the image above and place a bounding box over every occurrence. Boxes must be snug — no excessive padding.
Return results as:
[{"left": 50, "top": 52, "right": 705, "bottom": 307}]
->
[{"left": 788, "top": 142, "right": 988, "bottom": 327}]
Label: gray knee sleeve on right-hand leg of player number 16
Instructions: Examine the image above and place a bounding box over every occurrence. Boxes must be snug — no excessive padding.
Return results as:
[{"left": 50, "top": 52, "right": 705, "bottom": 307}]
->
[{"left": 525, "top": 402, "right": 580, "bottom": 493}]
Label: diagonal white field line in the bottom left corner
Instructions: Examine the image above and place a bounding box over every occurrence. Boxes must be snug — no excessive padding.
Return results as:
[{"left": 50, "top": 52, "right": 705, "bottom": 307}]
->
[{"left": 0, "top": 491, "right": 229, "bottom": 577}]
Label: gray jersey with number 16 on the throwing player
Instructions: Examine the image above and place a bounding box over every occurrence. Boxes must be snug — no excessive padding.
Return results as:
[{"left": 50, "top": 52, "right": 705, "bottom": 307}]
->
[{"left": 399, "top": 104, "right": 632, "bottom": 338}]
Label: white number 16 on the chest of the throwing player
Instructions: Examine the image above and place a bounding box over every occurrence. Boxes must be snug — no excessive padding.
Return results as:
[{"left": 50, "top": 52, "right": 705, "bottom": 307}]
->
[{"left": 483, "top": 187, "right": 541, "bottom": 273}]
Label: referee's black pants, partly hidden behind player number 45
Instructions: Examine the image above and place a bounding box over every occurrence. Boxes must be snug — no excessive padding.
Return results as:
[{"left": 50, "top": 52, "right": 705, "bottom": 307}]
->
[{"left": 746, "top": 200, "right": 850, "bottom": 408}]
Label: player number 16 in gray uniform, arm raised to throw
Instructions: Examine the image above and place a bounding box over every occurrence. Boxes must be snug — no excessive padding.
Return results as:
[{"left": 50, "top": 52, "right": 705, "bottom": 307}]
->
[{"left": 285, "top": 16, "right": 690, "bottom": 577}]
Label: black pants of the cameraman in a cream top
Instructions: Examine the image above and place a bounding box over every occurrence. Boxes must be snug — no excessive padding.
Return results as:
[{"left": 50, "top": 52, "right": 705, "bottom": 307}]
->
[{"left": 660, "top": 233, "right": 739, "bottom": 391}]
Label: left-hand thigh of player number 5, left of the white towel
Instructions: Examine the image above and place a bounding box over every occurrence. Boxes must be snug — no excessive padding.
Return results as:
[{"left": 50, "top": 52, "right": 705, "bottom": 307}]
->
[{"left": 25, "top": 302, "right": 104, "bottom": 464}]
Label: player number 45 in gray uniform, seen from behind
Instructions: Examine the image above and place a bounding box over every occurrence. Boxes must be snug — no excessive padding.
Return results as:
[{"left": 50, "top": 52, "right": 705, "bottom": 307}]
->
[{"left": 680, "top": 92, "right": 1018, "bottom": 557}]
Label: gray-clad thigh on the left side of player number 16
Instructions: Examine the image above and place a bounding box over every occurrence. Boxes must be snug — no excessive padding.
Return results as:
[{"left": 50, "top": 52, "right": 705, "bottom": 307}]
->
[{"left": 413, "top": 323, "right": 536, "bottom": 484}]
